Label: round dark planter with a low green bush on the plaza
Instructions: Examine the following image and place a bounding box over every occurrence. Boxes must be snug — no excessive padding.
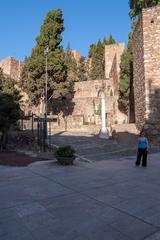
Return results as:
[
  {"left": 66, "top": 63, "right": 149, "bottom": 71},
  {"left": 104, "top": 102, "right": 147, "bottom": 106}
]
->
[{"left": 55, "top": 146, "right": 75, "bottom": 165}]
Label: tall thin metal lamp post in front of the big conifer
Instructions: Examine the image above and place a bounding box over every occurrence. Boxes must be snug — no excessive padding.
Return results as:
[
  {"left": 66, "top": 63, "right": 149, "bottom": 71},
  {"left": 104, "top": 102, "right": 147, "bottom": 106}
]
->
[{"left": 44, "top": 47, "right": 49, "bottom": 151}]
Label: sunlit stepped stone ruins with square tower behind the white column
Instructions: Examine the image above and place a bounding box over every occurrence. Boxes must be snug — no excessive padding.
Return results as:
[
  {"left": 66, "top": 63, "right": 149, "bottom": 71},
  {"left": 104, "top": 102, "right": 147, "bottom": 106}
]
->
[{"left": 48, "top": 43, "right": 128, "bottom": 128}]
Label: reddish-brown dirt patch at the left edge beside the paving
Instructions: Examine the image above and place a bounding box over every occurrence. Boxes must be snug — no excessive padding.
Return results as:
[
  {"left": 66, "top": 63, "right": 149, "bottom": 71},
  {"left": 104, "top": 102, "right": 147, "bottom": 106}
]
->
[{"left": 0, "top": 151, "right": 40, "bottom": 167}]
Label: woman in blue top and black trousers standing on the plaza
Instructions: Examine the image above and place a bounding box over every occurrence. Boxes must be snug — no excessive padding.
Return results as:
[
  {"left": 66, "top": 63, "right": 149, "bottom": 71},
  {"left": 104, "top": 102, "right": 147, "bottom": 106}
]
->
[{"left": 136, "top": 131, "right": 148, "bottom": 167}]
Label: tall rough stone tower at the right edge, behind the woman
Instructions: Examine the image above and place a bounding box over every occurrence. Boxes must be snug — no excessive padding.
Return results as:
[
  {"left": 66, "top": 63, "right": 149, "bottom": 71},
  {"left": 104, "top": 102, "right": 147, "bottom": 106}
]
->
[{"left": 133, "top": 6, "right": 160, "bottom": 134}]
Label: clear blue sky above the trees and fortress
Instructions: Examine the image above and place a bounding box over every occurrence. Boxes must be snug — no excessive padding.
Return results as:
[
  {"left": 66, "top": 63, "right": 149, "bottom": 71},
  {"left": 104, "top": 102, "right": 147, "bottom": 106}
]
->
[{"left": 0, "top": 0, "right": 130, "bottom": 60}]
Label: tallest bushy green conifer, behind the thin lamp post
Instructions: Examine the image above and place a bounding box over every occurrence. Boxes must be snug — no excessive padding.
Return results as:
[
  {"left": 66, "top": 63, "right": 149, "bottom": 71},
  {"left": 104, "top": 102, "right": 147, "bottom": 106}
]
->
[{"left": 20, "top": 9, "right": 68, "bottom": 104}]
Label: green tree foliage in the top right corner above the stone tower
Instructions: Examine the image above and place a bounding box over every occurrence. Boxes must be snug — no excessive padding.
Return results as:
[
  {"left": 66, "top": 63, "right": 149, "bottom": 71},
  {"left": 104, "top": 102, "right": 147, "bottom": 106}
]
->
[{"left": 129, "top": 0, "right": 160, "bottom": 19}]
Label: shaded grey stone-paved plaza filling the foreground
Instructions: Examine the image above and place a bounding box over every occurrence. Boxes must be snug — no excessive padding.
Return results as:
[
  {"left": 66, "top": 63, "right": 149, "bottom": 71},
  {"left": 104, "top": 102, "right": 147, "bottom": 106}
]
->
[{"left": 0, "top": 133, "right": 160, "bottom": 240}]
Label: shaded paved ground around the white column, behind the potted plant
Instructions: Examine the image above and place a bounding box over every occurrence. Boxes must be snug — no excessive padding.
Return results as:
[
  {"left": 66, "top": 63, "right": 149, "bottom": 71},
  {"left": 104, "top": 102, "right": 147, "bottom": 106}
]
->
[{"left": 50, "top": 132, "right": 159, "bottom": 162}]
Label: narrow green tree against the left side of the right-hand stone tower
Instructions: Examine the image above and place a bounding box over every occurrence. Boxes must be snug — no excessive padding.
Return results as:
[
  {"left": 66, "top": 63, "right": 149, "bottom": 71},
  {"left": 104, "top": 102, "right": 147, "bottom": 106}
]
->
[{"left": 118, "top": 33, "right": 133, "bottom": 114}]
